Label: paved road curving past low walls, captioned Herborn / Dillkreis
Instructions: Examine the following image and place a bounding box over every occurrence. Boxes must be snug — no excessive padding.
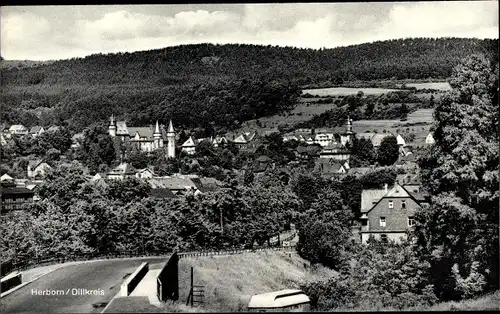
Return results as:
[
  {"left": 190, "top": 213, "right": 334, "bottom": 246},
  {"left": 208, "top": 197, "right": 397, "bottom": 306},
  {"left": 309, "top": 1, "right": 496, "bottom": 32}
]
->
[{"left": 0, "top": 257, "right": 167, "bottom": 313}]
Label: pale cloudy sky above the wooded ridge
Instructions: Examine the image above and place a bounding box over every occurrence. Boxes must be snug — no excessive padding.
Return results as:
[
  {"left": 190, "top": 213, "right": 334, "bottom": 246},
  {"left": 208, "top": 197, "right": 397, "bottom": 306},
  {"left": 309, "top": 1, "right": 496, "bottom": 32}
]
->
[{"left": 0, "top": 1, "right": 498, "bottom": 60}]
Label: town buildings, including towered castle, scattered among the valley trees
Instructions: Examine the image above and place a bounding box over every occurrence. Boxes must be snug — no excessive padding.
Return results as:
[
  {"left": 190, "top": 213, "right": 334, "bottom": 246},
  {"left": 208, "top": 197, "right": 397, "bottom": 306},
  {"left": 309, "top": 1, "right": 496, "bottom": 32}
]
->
[{"left": 0, "top": 116, "right": 434, "bottom": 247}]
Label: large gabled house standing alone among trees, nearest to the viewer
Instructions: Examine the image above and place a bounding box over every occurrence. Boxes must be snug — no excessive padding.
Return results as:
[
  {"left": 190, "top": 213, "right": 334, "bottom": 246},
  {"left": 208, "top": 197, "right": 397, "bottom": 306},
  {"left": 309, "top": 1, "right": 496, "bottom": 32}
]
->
[{"left": 360, "top": 183, "right": 426, "bottom": 243}]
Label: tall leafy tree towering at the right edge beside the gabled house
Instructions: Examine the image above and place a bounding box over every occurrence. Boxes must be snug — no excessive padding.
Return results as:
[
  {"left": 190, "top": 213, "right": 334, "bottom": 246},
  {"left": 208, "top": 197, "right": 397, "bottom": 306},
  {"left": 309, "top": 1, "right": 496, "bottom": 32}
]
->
[{"left": 417, "top": 55, "right": 499, "bottom": 299}]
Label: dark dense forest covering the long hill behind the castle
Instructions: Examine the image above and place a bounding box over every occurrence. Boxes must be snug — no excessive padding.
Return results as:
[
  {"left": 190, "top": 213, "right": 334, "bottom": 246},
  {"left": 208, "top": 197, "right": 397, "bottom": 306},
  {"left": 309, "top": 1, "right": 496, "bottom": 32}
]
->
[{"left": 0, "top": 38, "right": 498, "bottom": 133}]
